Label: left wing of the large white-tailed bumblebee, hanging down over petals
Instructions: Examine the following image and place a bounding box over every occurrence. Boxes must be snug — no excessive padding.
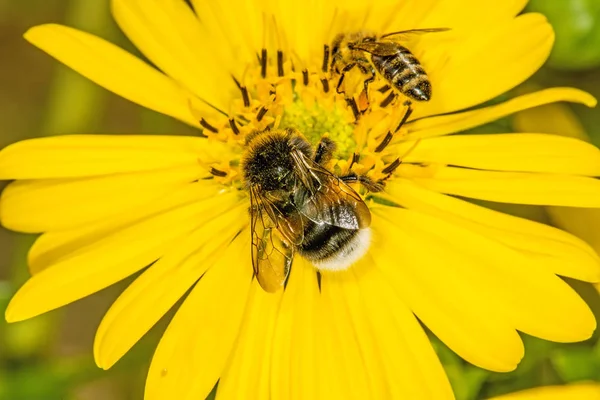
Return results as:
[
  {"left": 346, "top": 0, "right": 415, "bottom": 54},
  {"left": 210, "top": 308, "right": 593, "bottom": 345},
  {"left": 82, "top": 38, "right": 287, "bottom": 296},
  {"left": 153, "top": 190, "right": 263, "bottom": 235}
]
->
[{"left": 250, "top": 190, "right": 294, "bottom": 293}]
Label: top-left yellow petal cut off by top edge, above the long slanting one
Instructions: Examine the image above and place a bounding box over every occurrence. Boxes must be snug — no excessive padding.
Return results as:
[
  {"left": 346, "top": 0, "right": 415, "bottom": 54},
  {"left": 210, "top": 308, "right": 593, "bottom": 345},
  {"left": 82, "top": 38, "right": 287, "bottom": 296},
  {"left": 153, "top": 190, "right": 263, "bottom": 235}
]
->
[{"left": 111, "top": 0, "right": 237, "bottom": 112}]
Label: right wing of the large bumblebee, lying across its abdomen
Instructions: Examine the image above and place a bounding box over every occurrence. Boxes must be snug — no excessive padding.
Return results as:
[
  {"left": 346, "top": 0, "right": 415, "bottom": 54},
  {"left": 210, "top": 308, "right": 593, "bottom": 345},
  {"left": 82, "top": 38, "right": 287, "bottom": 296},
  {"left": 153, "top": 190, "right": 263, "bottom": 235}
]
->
[{"left": 294, "top": 165, "right": 371, "bottom": 229}]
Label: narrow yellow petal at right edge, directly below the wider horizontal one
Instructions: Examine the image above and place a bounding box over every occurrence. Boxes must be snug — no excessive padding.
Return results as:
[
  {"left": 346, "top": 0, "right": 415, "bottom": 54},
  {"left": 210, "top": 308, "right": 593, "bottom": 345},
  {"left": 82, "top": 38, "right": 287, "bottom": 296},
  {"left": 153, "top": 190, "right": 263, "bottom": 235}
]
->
[{"left": 408, "top": 165, "right": 600, "bottom": 208}]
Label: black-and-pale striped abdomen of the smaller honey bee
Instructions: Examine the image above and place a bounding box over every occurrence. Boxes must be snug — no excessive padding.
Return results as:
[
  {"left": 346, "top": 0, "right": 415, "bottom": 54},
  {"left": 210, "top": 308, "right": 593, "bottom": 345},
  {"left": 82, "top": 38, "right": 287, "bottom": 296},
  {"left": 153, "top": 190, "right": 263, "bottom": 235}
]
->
[{"left": 371, "top": 45, "right": 431, "bottom": 101}]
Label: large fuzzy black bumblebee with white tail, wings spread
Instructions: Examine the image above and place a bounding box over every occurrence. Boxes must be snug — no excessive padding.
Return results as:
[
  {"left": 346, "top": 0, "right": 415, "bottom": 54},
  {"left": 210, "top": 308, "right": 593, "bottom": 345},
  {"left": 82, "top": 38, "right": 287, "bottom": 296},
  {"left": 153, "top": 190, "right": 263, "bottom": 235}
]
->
[{"left": 241, "top": 129, "right": 384, "bottom": 292}]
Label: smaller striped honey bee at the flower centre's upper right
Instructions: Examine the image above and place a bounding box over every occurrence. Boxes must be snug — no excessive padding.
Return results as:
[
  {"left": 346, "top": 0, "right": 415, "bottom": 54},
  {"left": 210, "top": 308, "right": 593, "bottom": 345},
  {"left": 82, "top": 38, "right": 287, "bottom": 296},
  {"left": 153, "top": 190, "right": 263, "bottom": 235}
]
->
[{"left": 331, "top": 28, "right": 448, "bottom": 101}]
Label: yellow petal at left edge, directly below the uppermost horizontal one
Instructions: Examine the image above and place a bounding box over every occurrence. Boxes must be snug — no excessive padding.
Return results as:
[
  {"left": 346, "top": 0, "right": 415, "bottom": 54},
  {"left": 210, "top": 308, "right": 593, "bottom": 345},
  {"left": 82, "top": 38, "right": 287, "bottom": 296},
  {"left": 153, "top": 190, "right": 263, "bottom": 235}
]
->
[{"left": 0, "top": 166, "right": 199, "bottom": 233}]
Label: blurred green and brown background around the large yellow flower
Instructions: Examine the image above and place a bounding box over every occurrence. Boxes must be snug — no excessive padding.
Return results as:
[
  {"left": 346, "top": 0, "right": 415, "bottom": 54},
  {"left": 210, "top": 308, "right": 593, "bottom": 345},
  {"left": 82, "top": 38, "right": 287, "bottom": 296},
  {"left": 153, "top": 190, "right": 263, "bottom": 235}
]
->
[{"left": 0, "top": 0, "right": 600, "bottom": 400}]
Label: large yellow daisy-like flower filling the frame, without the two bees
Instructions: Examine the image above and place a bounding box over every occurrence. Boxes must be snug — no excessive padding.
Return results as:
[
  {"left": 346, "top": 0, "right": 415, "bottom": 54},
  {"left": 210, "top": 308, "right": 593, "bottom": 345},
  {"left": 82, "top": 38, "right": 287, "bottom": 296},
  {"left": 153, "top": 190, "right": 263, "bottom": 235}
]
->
[{"left": 0, "top": 0, "right": 600, "bottom": 400}]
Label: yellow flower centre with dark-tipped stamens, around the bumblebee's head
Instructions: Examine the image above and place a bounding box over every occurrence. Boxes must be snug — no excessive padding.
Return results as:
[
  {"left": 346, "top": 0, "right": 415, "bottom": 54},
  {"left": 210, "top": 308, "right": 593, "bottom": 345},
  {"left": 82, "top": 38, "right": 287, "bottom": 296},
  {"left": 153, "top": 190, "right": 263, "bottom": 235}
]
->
[{"left": 195, "top": 46, "right": 420, "bottom": 187}]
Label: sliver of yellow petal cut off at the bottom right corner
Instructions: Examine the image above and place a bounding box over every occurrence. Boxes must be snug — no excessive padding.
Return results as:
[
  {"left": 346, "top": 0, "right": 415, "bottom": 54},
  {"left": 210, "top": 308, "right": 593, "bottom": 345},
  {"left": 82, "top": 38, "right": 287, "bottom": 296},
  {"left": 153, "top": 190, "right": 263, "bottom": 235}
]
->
[{"left": 490, "top": 382, "right": 600, "bottom": 400}]
